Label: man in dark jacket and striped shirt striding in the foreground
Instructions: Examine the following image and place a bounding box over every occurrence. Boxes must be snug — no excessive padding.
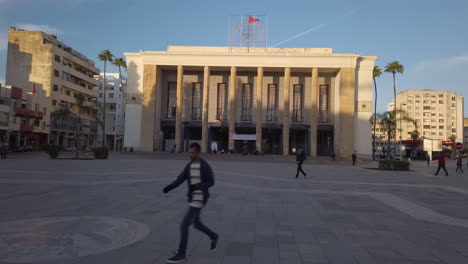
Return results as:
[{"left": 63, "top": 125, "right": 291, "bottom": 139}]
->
[{"left": 163, "top": 143, "right": 219, "bottom": 263}]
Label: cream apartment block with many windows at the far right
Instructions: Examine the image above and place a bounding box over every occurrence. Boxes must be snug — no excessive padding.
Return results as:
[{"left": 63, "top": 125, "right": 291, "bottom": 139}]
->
[{"left": 388, "top": 90, "right": 464, "bottom": 141}]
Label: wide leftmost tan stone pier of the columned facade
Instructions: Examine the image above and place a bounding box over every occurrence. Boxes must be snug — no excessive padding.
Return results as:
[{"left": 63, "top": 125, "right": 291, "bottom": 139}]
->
[{"left": 140, "top": 65, "right": 157, "bottom": 152}]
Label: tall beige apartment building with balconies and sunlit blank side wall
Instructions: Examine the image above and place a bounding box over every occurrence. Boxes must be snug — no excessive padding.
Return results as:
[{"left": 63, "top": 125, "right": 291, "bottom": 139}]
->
[{"left": 6, "top": 27, "right": 99, "bottom": 146}]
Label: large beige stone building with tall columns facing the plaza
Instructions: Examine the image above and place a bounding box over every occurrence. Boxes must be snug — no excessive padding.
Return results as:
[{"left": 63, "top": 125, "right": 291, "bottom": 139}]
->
[{"left": 124, "top": 46, "right": 377, "bottom": 157}]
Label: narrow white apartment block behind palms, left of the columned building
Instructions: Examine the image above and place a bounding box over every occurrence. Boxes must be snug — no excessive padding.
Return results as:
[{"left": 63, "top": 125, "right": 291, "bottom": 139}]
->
[{"left": 95, "top": 73, "right": 127, "bottom": 150}]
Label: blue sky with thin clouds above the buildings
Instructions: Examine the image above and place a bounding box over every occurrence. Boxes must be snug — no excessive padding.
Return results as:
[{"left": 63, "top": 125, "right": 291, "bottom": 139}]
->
[{"left": 0, "top": 0, "right": 468, "bottom": 115}]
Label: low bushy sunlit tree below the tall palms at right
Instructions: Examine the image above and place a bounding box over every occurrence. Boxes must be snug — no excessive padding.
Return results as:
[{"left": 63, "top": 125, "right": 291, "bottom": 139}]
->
[{"left": 369, "top": 109, "right": 416, "bottom": 160}]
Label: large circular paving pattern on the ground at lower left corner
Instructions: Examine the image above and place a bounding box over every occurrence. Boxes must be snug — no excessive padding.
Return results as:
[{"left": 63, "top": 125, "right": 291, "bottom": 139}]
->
[{"left": 0, "top": 217, "right": 149, "bottom": 263}]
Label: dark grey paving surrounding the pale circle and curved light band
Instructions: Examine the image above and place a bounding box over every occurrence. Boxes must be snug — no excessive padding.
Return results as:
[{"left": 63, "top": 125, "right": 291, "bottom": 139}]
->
[{"left": 0, "top": 156, "right": 468, "bottom": 264}]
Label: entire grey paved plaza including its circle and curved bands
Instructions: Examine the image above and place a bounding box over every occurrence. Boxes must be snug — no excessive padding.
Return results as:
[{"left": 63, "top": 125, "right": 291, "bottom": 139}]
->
[{"left": 0, "top": 154, "right": 468, "bottom": 264}]
